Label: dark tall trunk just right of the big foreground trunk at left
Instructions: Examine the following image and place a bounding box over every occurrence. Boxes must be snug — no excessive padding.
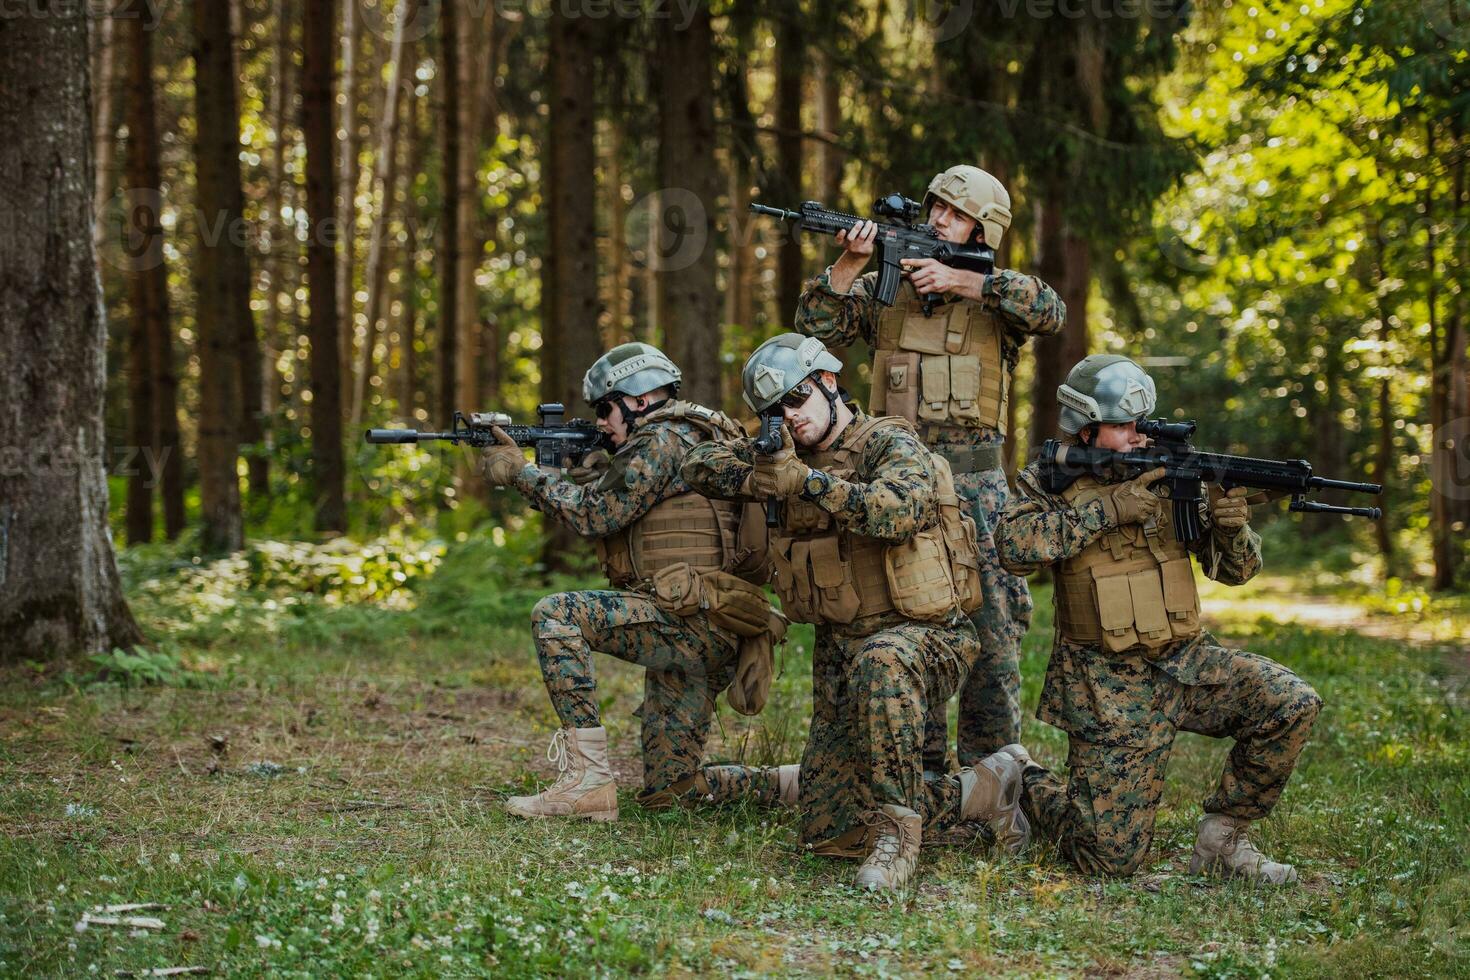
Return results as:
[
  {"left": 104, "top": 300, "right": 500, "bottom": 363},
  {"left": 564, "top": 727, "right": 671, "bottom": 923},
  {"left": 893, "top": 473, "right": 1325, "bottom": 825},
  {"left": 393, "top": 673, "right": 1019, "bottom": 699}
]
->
[{"left": 119, "top": 4, "right": 184, "bottom": 541}]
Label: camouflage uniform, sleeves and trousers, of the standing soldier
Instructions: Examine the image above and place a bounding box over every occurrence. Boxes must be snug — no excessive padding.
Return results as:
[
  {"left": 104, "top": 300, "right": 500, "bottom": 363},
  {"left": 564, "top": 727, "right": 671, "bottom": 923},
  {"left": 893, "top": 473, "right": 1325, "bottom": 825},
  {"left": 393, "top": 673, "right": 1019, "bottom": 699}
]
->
[{"left": 795, "top": 269, "right": 1066, "bottom": 770}]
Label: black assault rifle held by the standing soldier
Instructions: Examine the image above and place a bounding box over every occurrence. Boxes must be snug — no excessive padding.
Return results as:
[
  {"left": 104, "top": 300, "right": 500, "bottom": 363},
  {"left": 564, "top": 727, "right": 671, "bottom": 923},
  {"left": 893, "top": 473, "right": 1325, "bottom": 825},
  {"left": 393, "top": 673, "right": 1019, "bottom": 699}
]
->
[{"left": 750, "top": 194, "right": 995, "bottom": 316}]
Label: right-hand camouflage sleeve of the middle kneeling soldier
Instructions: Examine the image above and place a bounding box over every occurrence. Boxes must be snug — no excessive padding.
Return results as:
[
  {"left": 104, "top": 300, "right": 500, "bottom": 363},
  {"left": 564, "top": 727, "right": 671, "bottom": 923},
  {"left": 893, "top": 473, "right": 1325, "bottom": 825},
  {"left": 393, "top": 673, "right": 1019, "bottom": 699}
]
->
[{"left": 816, "top": 428, "right": 939, "bottom": 541}]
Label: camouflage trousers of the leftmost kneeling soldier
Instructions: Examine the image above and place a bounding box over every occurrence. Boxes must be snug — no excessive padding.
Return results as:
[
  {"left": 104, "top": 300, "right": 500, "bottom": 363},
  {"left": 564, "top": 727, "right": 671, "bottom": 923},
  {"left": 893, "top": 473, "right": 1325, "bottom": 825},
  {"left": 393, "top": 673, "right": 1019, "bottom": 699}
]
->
[{"left": 531, "top": 591, "right": 778, "bottom": 804}]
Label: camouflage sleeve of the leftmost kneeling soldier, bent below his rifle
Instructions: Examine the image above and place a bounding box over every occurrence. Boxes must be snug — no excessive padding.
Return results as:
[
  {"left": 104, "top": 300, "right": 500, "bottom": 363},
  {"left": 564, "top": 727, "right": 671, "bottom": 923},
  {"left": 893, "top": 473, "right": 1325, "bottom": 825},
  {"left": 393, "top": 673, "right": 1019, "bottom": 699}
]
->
[{"left": 515, "top": 425, "right": 685, "bottom": 538}]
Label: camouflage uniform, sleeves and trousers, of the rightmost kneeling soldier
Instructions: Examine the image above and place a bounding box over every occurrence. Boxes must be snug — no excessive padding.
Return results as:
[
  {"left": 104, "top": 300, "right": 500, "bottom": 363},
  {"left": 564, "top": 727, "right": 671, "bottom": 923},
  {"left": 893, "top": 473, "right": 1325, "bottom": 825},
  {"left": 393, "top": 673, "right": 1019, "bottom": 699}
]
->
[{"left": 995, "top": 464, "right": 1322, "bottom": 874}]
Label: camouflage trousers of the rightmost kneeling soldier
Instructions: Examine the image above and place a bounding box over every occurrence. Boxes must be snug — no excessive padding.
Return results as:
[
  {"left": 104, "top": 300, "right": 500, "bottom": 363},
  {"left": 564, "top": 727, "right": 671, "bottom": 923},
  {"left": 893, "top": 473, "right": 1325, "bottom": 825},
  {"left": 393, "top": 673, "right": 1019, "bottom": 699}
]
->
[{"left": 1022, "top": 651, "right": 1322, "bottom": 874}]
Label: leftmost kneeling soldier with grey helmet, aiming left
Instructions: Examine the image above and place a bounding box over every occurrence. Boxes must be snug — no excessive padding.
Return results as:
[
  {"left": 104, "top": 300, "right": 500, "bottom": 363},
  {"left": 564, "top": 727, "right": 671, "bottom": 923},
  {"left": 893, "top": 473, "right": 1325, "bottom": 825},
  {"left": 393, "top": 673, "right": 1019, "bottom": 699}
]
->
[{"left": 481, "top": 344, "right": 798, "bottom": 820}]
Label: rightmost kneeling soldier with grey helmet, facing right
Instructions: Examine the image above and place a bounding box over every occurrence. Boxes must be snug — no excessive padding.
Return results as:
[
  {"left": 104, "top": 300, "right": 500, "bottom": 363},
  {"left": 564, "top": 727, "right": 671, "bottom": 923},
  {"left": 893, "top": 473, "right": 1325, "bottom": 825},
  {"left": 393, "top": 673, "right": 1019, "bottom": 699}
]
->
[{"left": 995, "top": 354, "right": 1322, "bottom": 884}]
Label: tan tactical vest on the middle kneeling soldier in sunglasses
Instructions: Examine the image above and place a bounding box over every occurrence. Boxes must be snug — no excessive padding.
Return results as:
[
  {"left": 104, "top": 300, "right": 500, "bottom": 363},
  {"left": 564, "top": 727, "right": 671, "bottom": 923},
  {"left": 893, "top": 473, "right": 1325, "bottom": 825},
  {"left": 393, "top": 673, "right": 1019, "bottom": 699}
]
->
[{"left": 770, "top": 417, "right": 982, "bottom": 624}]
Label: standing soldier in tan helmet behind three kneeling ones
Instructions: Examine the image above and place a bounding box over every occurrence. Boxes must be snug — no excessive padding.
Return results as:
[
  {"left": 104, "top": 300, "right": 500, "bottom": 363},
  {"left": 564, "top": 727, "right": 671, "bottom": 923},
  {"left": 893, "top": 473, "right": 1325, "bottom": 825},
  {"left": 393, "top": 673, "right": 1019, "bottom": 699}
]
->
[{"left": 797, "top": 166, "right": 1066, "bottom": 770}]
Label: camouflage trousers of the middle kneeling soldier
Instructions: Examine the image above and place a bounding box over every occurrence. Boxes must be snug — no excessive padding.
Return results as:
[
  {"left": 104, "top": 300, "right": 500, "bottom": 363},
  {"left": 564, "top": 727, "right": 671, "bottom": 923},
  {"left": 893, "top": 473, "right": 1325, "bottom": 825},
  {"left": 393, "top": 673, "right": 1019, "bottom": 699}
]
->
[{"left": 801, "top": 623, "right": 976, "bottom": 855}]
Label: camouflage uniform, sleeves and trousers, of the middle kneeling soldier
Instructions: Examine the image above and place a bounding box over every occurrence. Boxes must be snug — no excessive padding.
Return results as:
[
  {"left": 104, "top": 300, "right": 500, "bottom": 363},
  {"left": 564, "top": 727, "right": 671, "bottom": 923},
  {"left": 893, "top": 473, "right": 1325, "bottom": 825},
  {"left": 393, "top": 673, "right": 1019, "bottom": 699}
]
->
[{"left": 684, "top": 407, "right": 979, "bottom": 857}]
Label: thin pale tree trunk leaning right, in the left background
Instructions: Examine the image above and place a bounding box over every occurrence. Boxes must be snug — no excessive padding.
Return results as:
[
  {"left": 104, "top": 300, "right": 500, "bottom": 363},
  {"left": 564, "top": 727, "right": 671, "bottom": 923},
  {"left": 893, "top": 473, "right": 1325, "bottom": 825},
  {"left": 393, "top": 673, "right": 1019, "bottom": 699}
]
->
[{"left": 347, "top": 0, "right": 415, "bottom": 432}]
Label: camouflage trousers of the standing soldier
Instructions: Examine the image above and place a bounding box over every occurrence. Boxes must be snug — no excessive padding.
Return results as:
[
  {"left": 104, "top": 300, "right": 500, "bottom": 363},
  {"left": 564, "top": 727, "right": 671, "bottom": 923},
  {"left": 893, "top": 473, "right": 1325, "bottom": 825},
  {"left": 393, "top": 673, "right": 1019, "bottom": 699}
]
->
[{"left": 923, "top": 470, "right": 1032, "bottom": 771}]
